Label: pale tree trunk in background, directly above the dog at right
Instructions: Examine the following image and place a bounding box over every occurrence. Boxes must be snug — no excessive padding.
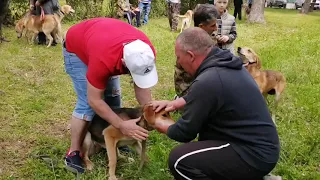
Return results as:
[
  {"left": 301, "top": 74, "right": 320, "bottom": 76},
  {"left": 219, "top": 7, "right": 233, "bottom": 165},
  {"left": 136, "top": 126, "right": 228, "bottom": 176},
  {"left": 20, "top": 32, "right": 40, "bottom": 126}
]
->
[{"left": 247, "top": 0, "right": 265, "bottom": 23}]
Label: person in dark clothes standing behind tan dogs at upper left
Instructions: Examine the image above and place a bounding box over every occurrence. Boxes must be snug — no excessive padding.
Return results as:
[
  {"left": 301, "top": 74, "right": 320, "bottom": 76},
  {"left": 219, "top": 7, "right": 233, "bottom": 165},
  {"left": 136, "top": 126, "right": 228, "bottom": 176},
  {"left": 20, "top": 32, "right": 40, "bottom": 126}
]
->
[{"left": 30, "top": 0, "right": 60, "bottom": 46}]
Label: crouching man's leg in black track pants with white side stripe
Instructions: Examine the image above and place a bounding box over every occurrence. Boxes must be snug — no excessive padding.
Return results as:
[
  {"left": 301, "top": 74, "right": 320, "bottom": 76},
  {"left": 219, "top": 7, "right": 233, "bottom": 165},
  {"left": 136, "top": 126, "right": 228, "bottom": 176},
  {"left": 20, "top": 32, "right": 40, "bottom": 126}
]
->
[{"left": 168, "top": 141, "right": 268, "bottom": 180}]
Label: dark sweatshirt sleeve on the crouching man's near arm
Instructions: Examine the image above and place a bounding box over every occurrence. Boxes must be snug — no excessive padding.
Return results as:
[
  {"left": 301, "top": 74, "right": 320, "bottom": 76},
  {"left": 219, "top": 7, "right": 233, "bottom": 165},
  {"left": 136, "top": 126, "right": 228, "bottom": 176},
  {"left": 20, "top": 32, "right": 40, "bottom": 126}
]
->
[{"left": 167, "top": 71, "right": 222, "bottom": 142}]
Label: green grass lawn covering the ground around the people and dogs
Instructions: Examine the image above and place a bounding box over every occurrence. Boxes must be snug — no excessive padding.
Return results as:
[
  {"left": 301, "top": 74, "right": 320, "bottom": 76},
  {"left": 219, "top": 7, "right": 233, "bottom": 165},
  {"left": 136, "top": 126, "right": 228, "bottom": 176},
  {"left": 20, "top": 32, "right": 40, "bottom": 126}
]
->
[{"left": 0, "top": 9, "right": 320, "bottom": 180}]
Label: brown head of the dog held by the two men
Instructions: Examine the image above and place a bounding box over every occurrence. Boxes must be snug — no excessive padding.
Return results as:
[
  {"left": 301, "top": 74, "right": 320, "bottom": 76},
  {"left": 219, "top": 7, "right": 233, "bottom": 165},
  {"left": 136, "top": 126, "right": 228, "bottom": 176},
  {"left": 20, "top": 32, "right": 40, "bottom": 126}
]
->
[{"left": 139, "top": 104, "right": 173, "bottom": 131}]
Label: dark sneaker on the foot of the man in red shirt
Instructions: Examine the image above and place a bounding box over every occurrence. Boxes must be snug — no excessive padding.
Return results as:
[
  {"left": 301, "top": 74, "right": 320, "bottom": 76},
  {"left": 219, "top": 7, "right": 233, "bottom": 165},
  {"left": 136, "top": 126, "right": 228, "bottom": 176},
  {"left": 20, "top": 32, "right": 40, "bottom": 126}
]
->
[{"left": 64, "top": 151, "right": 84, "bottom": 173}]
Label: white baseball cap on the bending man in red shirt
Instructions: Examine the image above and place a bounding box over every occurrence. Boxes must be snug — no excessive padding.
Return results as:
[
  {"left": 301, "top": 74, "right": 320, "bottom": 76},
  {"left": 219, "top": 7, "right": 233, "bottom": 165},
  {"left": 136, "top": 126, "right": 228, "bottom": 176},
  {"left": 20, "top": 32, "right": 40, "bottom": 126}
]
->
[{"left": 123, "top": 39, "right": 158, "bottom": 88}]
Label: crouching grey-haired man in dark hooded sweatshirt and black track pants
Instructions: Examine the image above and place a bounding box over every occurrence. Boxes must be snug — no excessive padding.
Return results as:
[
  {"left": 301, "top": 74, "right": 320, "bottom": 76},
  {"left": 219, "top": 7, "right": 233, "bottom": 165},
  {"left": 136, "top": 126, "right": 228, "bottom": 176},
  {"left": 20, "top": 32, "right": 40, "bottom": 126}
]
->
[{"left": 151, "top": 27, "right": 280, "bottom": 180}]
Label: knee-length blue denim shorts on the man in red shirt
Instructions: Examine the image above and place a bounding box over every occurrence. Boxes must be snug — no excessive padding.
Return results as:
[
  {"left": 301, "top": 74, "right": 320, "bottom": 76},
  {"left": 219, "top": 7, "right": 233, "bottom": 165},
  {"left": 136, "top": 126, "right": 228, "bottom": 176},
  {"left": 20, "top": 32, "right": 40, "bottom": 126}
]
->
[{"left": 63, "top": 48, "right": 121, "bottom": 121}]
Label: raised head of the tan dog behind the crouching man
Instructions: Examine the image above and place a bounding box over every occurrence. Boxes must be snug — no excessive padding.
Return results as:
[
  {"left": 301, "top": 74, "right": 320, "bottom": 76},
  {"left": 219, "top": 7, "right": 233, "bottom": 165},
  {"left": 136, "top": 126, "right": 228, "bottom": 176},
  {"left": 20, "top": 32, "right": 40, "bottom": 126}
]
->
[{"left": 237, "top": 47, "right": 261, "bottom": 69}]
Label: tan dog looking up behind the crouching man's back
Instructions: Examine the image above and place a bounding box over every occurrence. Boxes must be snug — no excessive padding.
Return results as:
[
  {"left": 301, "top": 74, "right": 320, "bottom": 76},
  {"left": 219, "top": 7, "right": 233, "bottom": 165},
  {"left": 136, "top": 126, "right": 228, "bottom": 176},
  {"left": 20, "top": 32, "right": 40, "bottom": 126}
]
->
[{"left": 238, "top": 47, "right": 286, "bottom": 122}]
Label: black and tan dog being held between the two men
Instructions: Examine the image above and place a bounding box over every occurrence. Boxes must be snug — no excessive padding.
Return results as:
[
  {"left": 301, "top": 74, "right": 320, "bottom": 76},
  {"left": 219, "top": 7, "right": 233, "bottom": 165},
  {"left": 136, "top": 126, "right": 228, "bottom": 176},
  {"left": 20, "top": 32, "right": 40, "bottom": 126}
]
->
[{"left": 82, "top": 104, "right": 174, "bottom": 180}]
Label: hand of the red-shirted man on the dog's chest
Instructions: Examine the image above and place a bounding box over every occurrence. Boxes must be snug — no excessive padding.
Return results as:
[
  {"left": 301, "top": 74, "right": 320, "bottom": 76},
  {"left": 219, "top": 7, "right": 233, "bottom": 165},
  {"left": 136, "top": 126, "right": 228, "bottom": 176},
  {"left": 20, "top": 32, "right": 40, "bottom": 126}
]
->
[{"left": 119, "top": 118, "right": 148, "bottom": 140}]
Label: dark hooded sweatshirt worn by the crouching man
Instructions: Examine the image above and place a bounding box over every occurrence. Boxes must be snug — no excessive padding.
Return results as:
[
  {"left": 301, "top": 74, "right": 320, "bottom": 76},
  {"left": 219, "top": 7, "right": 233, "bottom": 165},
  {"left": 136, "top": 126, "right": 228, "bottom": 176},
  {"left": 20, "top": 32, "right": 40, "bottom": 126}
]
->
[{"left": 167, "top": 47, "right": 280, "bottom": 171}]
